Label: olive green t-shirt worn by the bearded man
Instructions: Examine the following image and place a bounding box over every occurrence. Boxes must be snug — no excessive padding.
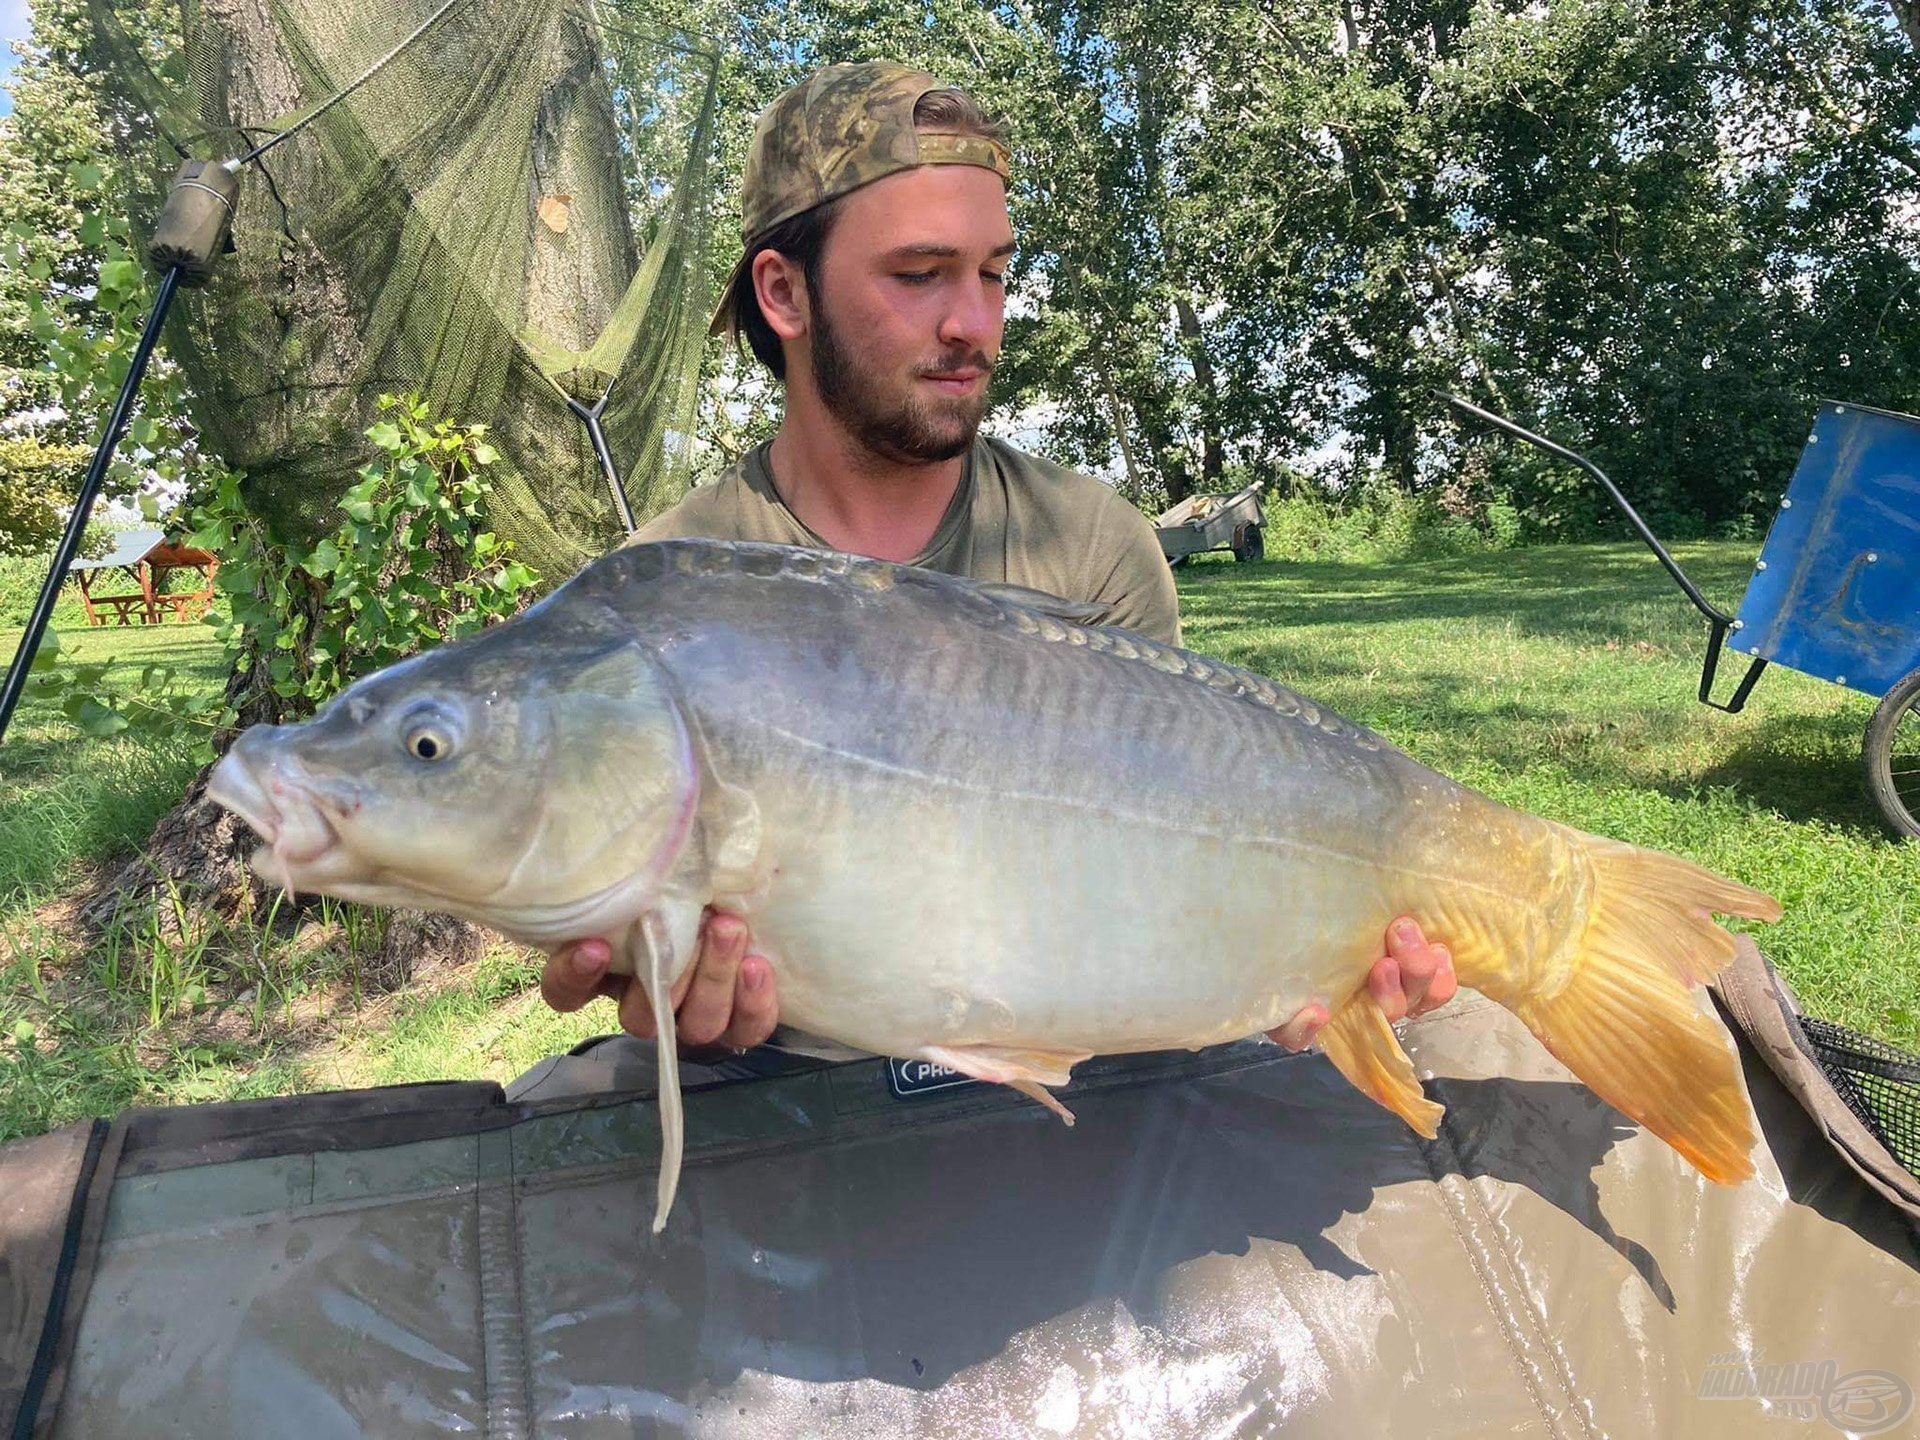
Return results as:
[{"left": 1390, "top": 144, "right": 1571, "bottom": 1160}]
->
[{"left": 634, "top": 436, "right": 1181, "bottom": 645}]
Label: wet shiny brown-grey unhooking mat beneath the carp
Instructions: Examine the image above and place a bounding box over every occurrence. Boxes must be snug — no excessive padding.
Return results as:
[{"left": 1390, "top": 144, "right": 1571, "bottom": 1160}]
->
[{"left": 0, "top": 947, "right": 1920, "bottom": 1440}]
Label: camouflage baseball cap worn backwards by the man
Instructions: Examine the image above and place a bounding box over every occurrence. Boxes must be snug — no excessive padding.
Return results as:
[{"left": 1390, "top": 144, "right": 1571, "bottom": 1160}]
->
[{"left": 708, "top": 60, "right": 1012, "bottom": 334}]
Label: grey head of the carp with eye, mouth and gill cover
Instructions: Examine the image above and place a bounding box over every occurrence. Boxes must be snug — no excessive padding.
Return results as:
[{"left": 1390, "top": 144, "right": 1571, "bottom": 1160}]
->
[{"left": 207, "top": 616, "right": 699, "bottom": 947}]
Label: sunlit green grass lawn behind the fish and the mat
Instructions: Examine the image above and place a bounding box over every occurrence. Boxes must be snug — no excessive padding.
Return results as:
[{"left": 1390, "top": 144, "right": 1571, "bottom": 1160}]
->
[{"left": 0, "top": 543, "right": 1920, "bottom": 1139}]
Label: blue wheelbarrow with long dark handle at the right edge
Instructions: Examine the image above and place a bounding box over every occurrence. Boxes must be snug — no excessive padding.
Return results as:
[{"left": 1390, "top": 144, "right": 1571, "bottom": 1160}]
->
[{"left": 1442, "top": 396, "right": 1920, "bottom": 837}]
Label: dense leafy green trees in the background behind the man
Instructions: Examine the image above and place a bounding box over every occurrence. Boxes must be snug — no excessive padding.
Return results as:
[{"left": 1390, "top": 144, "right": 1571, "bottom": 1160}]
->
[{"left": 0, "top": 0, "right": 1920, "bottom": 536}]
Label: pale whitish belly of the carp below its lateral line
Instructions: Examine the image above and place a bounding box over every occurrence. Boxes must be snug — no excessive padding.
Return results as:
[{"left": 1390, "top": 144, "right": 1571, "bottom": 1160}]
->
[{"left": 706, "top": 748, "right": 1559, "bottom": 1054}]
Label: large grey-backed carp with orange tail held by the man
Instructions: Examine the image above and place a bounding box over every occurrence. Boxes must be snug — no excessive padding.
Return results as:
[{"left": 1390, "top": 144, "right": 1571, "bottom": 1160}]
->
[{"left": 209, "top": 541, "right": 1780, "bottom": 1229}]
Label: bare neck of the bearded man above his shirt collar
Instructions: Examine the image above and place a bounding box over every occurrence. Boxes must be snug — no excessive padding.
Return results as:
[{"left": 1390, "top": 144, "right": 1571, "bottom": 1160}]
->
[{"left": 768, "top": 405, "right": 966, "bottom": 561}]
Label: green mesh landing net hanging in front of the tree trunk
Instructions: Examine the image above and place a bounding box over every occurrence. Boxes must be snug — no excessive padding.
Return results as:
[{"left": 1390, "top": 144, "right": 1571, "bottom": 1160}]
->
[{"left": 76, "top": 0, "right": 718, "bottom": 578}]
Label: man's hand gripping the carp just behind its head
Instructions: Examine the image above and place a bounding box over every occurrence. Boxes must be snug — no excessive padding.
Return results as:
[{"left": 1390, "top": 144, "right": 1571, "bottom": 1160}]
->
[{"left": 540, "top": 910, "right": 780, "bottom": 1050}]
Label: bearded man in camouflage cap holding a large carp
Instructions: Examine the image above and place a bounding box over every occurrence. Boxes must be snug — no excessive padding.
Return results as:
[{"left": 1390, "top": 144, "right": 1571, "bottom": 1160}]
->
[{"left": 526, "top": 61, "right": 1455, "bottom": 1050}]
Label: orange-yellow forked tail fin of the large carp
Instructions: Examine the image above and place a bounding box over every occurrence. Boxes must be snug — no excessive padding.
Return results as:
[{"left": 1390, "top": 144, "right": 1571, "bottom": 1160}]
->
[{"left": 1455, "top": 829, "right": 1780, "bottom": 1185}]
